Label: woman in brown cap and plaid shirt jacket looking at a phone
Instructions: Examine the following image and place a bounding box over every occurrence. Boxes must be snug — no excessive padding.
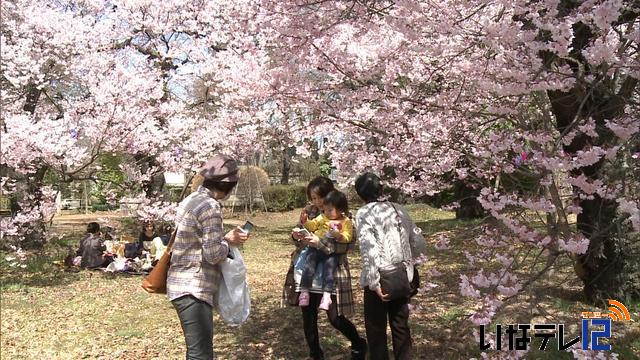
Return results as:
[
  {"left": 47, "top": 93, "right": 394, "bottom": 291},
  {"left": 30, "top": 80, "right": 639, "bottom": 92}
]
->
[{"left": 167, "top": 155, "right": 248, "bottom": 360}]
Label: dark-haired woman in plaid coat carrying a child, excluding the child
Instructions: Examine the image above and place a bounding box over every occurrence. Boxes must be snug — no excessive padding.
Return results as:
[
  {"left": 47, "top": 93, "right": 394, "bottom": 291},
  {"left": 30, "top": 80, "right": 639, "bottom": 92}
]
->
[{"left": 282, "top": 176, "right": 367, "bottom": 359}]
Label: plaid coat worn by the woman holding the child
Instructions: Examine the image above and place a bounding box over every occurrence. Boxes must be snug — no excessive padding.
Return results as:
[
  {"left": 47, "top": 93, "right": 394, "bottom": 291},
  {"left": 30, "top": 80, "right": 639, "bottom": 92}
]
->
[{"left": 280, "top": 208, "right": 355, "bottom": 317}]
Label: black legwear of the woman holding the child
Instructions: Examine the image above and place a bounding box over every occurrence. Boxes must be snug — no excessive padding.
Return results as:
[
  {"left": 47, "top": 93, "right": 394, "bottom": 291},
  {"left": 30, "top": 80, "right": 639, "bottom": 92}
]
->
[{"left": 300, "top": 293, "right": 362, "bottom": 359}]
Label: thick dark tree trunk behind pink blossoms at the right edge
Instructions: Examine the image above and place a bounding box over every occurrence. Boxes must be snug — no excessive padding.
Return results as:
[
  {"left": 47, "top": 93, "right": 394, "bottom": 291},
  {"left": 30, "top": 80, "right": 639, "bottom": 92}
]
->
[{"left": 540, "top": 0, "right": 640, "bottom": 303}]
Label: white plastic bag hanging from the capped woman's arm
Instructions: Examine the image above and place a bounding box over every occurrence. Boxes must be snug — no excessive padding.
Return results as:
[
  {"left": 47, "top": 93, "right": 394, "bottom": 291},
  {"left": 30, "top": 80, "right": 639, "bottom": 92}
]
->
[{"left": 218, "top": 247, "right": 251, "bottom": 326}]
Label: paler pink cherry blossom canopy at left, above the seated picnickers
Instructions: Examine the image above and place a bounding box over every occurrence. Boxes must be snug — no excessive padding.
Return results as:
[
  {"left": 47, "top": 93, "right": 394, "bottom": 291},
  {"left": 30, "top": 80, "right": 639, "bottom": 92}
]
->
[{"left": 0, "top": 1, "right": 262, "bottom": 248}]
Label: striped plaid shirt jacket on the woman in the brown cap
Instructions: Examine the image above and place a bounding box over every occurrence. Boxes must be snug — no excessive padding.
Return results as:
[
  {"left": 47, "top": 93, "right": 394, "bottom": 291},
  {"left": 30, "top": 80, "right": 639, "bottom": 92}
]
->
[{"left": 167, "top": 186, "right": 229, "bottom": 307}]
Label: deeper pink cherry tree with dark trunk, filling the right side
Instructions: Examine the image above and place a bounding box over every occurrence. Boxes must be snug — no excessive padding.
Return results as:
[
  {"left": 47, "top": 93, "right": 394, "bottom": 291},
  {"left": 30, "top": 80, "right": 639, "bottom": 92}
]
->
[{"left": 261, "top": 0, "right": 640, "bottom": 344}]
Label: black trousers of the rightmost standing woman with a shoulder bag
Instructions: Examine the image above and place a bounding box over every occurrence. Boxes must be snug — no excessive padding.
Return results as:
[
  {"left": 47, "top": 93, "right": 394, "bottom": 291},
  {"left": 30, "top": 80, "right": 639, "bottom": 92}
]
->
[{"left": 364, "top": 287, "right": 413, "bottom": 360}]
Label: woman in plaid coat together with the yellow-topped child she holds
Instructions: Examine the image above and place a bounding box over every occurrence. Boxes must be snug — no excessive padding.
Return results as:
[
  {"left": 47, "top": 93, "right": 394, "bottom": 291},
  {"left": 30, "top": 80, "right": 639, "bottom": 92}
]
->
[{"left": 283, "top": 177, "right": 367, "bottom": 359}]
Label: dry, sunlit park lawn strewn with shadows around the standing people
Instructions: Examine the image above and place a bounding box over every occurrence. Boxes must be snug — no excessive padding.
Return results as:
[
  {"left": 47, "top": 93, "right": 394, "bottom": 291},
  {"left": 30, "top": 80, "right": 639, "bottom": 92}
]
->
[{"left": 0, "top": 205, "right": 640, "bottom": 359}]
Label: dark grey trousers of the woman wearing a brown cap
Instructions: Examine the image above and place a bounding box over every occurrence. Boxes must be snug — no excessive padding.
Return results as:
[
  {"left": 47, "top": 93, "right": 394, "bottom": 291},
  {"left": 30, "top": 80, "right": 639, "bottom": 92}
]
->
[{"left": 171, "top": 295, "right": 213, "bottom": 360}]
